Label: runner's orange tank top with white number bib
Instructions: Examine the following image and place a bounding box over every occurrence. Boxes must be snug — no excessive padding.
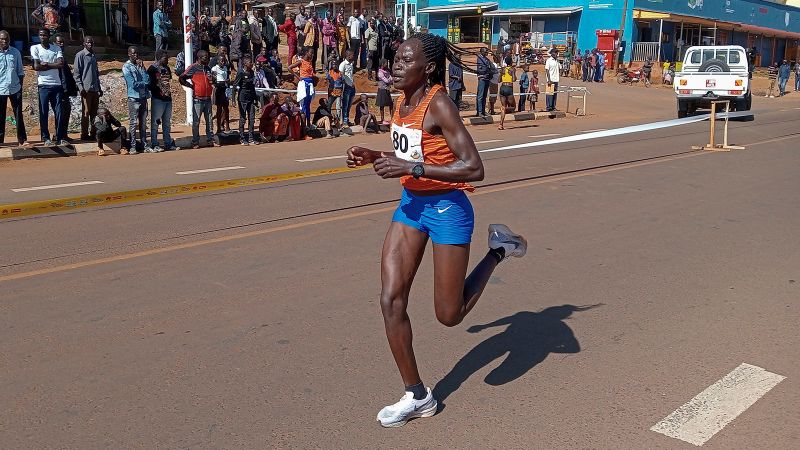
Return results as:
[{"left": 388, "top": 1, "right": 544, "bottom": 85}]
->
[{"left": 391, "top": 84, "right": 475, "bottom": 192}]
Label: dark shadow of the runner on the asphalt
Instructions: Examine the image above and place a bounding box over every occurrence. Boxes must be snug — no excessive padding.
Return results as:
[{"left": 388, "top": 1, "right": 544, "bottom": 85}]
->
[{"left": 433, "top": 304, "right": 601, "bottom": 411}]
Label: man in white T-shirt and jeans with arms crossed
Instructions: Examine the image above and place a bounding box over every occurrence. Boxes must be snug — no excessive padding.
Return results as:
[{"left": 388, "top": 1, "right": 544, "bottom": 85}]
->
[{"left": 31, "top": 28, "right": 68, "bottom": 147}]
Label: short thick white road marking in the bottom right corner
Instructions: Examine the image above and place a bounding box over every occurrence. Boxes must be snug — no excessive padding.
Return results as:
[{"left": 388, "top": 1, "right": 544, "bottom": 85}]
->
[{"left": 650, "top": 363, "right": 786, "bottom": 446}]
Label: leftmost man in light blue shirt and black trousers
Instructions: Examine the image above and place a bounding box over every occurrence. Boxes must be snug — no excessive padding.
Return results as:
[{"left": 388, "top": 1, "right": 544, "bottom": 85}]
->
[{"left": 0, "top": 30, "right": 28, "bottom": 146}]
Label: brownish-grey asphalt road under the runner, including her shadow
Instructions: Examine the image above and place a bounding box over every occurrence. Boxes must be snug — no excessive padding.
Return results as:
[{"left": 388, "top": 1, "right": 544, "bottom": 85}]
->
[{"left": 0, "top": 89, "right": 800, "bottom": 449}]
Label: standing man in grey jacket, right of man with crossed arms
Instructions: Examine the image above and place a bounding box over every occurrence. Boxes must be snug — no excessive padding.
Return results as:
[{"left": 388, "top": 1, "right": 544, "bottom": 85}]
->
[{"left": 72, "top": 36, "right": 103, "bottom": 141}]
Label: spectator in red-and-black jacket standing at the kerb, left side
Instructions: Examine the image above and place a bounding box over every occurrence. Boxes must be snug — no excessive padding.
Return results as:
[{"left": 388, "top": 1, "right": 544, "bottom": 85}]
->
[{"left": 178, "top": 50, "right": 220, "bottom": 148}]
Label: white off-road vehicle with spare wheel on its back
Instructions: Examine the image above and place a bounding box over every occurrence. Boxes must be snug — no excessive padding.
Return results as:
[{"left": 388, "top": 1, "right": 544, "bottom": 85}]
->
[{"left": 673, "top": 45, "right": 753, "bottom": 117}]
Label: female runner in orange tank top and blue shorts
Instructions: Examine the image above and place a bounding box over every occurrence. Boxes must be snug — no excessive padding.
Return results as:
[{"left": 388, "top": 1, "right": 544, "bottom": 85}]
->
[{"left": 347, "top": 33, "right": 527, "bottom": 427}]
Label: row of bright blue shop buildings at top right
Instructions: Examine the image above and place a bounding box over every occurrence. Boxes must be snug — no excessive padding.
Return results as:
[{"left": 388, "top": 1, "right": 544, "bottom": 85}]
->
[{"left": 417, "top": 0, "right": 800, "bottom": 65}]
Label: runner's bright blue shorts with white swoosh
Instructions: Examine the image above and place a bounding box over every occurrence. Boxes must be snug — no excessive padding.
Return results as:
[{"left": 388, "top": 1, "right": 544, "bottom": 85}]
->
[{"left": 392, "top": 189, "right": 475, "bottom": 245}]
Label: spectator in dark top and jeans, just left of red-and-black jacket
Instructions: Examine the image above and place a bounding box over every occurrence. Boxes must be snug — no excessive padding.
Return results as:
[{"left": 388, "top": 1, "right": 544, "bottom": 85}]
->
[{"left": 147, "top": 50, "right": 180, "bottom": 152}]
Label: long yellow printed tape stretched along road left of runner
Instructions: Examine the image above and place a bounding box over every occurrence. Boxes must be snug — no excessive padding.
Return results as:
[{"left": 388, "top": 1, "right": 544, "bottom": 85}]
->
[{"left": 0, "top": 166, "right": 372, "bottom": 220}]
